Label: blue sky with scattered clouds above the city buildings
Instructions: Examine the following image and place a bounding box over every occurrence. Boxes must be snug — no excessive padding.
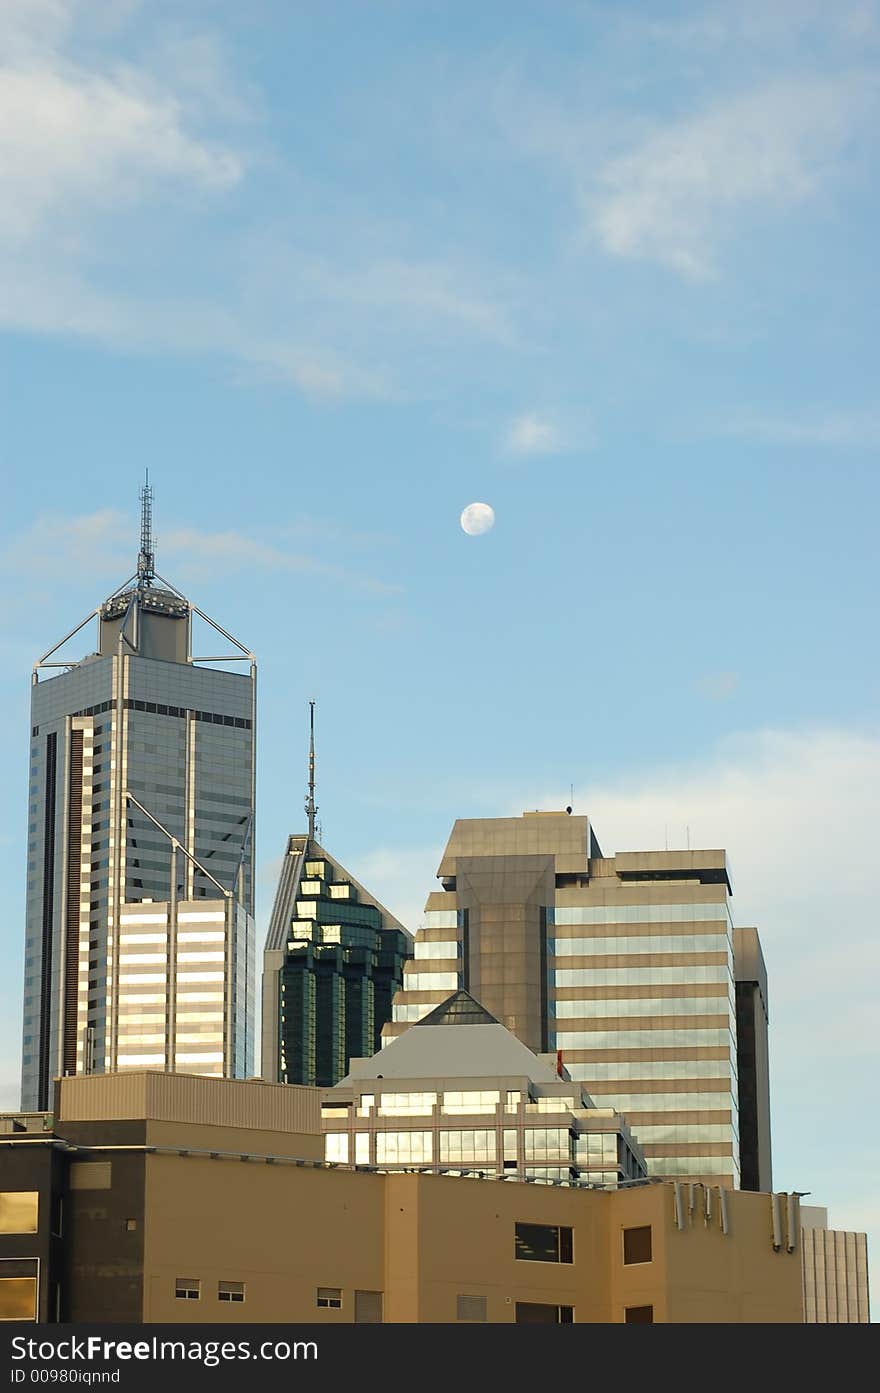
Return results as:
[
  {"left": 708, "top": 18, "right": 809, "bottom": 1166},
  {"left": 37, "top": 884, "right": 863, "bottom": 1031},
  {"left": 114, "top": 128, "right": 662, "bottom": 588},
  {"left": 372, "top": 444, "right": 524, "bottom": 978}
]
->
[{"left": 0, "top": 0, "right": 880, "bottom": 1314}]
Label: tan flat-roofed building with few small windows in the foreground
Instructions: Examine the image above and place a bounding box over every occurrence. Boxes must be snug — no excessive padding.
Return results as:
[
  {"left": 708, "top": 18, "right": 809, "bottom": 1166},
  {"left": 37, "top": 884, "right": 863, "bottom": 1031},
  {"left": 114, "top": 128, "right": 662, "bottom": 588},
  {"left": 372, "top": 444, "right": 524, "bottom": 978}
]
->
[{"left": 0, "top": 1073, "right": 802, "bottom": 1328}]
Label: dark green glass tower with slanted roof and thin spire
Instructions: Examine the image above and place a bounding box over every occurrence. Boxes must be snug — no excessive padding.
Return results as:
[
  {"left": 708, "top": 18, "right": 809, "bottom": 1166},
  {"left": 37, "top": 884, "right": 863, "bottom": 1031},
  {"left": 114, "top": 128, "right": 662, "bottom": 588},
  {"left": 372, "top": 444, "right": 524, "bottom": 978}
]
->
[{"left": 262, "top": 702, "right": 412, "bottom": 1088}]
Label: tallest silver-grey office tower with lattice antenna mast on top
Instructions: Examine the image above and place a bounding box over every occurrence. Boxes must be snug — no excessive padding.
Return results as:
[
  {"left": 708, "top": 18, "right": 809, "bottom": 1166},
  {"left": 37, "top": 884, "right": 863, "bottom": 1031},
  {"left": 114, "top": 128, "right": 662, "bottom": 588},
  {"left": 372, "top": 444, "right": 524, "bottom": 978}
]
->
[{"left": 22, "top": 486, "right": 256, "bottom": 1110}]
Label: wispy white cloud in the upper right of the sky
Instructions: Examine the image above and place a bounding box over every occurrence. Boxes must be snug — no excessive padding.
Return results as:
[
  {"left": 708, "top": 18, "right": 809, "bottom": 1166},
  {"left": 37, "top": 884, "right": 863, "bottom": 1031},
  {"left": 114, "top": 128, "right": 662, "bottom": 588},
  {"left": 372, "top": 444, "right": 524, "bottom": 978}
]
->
[{"left": 582, "top": 74, "right": 869, "bottom": 280}]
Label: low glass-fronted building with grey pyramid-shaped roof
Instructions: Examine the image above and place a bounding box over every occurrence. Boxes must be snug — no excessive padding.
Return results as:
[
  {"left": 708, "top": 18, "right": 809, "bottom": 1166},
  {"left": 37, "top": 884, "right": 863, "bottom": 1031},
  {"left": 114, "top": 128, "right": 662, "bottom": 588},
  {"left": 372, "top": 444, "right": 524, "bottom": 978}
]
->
[{"left": 322, "top": 990, "right": 646, "bottom": 1190}]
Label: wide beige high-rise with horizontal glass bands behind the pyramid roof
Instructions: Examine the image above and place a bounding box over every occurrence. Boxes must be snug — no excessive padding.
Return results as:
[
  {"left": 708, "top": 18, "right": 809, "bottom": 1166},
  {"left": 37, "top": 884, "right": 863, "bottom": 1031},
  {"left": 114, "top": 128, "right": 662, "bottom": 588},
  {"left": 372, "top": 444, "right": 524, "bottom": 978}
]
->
[{"left": 384, "top": 812, "right": 770, "bottom": 1188}]
